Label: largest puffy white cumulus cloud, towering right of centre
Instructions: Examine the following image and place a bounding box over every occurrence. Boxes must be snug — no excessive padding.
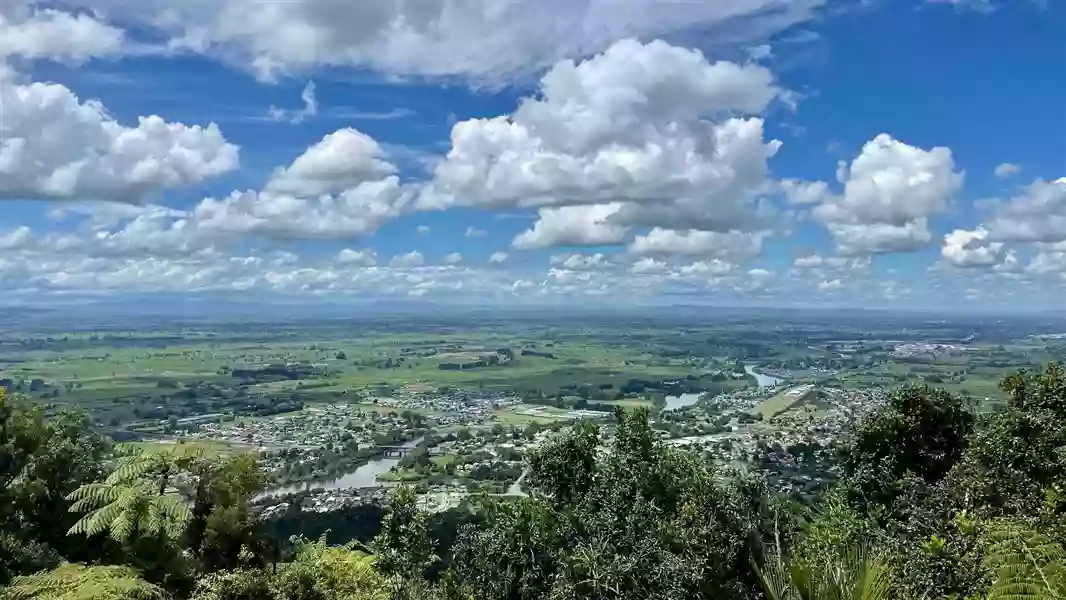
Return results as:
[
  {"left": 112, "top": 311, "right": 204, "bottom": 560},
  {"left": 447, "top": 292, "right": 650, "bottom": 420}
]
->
[{"left": 419, "top": 39, "right": 780, "bottom": 240}]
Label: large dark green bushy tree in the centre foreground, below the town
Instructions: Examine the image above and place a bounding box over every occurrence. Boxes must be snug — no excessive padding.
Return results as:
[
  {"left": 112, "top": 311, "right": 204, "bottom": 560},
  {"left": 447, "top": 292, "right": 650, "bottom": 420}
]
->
[{"left": 452, "top": 409, "right": 758, "bottom": 600}]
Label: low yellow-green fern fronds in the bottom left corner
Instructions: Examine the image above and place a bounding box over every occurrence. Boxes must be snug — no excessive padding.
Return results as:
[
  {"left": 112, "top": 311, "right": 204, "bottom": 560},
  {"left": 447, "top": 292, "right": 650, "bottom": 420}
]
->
[{"left": 0, "top": 565, "right": 167, "bottom": 600}]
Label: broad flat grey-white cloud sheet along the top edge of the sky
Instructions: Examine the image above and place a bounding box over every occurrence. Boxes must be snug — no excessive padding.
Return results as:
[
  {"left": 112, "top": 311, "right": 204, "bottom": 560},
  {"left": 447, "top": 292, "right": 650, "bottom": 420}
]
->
[{"left": 59, "top": 0, "right": 822, "bottom": 81}]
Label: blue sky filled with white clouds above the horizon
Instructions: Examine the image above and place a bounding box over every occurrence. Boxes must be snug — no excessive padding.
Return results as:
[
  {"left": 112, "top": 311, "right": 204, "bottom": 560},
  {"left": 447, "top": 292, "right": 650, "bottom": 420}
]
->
[{"left": 0, "top": 0, "right": 1066, "bottom": 310}]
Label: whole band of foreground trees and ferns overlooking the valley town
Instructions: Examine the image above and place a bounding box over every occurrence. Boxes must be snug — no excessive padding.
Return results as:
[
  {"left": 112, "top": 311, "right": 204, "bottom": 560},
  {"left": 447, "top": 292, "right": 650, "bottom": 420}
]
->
[{"left": 0, "top": 364, "right": 1066, "bottom": 600}]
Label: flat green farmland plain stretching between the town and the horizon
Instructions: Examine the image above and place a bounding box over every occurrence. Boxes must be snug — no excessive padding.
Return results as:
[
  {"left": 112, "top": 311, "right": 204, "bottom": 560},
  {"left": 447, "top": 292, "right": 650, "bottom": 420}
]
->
[{"left": 0, "top": 311, "right": 1066, "bottom": 433}]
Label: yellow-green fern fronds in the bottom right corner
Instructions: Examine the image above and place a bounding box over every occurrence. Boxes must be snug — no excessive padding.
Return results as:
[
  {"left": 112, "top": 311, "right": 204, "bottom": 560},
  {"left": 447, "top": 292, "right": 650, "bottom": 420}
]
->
[{"left": 985, "top": 525, "right": 1066, "bottom": 600}]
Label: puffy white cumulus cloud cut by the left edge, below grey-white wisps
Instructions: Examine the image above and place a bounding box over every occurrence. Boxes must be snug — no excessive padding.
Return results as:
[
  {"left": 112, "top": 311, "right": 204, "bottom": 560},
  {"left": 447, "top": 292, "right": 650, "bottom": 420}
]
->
[{"left": 0, "top": 77, "right": 239, "bottom": 202}]
